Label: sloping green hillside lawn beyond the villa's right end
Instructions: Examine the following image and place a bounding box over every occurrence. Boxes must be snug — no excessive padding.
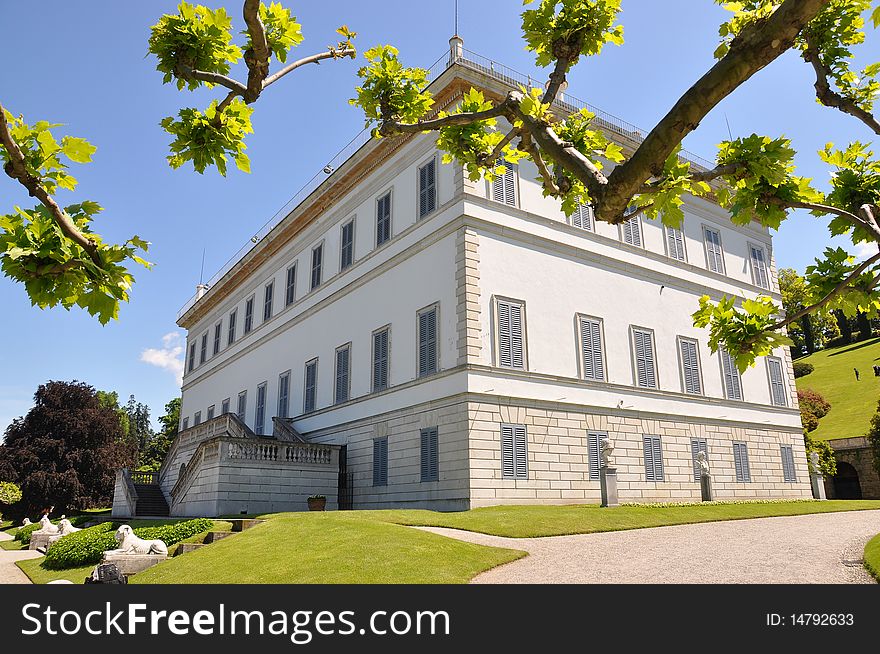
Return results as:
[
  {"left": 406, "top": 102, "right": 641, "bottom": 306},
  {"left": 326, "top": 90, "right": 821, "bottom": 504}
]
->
[{"left": 797, "top": 338, "right": 880, "bottom": 440}]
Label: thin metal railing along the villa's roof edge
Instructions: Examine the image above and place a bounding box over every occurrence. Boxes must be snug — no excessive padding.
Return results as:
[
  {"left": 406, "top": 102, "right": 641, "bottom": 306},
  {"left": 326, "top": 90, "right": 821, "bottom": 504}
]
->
[{"left": 176, "top": 49, "right": 714, "bottom": 320}]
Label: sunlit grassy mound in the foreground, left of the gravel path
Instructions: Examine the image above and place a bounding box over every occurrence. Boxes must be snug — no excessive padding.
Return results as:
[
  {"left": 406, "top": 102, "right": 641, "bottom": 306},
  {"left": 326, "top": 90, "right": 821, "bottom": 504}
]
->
[{"left": 130, "top": 511, "right": 525, "bottom": 584}]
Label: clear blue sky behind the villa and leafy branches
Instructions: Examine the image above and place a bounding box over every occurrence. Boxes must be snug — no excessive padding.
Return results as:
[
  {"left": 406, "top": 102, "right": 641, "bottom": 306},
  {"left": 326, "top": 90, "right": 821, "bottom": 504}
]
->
[{"left": 0, "top": 0, "right": 880, "bottom": 430}]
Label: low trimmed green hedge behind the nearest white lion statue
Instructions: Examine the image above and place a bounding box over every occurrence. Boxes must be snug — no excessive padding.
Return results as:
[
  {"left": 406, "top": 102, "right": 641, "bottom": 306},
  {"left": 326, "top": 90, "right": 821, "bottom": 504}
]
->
[{"left": 43, "top": 518, "right": 214, "bottom": 570}]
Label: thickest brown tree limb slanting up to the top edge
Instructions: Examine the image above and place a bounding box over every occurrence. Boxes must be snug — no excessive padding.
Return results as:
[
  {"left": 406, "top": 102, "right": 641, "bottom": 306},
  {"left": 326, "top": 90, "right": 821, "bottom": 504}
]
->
[{"left": 596, "top": 0, "right": 828, "bottom": 222}]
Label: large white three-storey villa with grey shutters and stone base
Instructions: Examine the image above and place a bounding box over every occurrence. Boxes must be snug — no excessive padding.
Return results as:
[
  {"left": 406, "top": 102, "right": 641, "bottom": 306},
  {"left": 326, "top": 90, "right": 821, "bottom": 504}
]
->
[{"left": 114, "top": 39, "right": 811, "bottom": 515}]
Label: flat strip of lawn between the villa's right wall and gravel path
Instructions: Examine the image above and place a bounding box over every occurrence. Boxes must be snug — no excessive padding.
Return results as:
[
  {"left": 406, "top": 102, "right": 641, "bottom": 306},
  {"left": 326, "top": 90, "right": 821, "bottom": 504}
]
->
[{"left": 378, "top": 500, "right": 880, "bottom": 538}]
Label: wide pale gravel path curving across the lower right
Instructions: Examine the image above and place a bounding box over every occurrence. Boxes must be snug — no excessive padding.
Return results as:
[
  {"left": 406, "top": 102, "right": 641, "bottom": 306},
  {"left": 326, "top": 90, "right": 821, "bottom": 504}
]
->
[{"left": 424, "top": 510, "right": 880, "bottom": 584}]
